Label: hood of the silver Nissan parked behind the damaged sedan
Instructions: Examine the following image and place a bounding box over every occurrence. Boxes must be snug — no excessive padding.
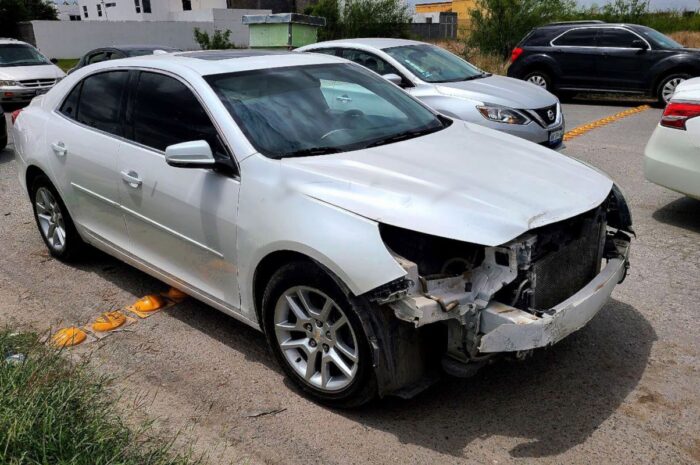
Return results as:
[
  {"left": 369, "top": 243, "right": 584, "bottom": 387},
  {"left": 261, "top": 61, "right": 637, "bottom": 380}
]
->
[{"left": 436, "top": 75, "right": 557, "bottom": 110}]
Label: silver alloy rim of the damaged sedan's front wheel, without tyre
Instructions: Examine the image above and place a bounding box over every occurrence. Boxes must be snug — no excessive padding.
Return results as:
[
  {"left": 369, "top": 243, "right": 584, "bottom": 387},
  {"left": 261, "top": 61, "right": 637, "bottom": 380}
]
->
[{"left": 274, "top": 286, "right": 360, "bottom": 392}]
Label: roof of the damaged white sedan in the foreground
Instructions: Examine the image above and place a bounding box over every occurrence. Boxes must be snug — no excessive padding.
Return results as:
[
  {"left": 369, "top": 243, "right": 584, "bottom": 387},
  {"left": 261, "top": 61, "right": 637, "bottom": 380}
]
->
[{"left": 86, "top": 49, "right": 347, "bottom": 76}]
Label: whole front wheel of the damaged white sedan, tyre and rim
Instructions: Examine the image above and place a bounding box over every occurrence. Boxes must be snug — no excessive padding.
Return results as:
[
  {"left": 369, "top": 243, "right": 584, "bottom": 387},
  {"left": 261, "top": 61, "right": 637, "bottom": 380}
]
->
[{"left": 262, "top": 262, "right": 377, "bottom": 408}]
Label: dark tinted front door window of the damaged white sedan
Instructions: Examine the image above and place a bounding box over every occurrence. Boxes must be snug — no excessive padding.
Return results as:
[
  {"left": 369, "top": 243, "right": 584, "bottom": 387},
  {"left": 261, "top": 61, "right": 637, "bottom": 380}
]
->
[{"left": 132, "top": 72, "right": 228, "bottom": 158}]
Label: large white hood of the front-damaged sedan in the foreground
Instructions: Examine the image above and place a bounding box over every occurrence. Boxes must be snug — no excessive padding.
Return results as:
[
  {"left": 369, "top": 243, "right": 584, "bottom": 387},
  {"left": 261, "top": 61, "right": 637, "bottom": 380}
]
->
[{"left": 281, "top": 121, "right": 613, "bottom": 246}]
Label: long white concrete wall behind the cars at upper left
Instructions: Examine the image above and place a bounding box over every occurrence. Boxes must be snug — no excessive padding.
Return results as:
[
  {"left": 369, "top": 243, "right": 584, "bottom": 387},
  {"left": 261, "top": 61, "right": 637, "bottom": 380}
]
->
[{"left": 23, "top": 10, "right": 270, "bottom": 58}]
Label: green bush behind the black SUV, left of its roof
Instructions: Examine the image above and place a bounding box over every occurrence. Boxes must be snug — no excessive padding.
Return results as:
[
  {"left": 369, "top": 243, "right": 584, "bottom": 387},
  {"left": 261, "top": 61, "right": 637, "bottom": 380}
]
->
[{"left": 467, "top": 0, "right": 576, "bottom": 57}]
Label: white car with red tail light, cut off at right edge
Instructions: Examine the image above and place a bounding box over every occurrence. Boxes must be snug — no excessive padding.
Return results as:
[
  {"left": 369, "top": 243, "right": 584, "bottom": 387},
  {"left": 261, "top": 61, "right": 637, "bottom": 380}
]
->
[{"left": 644, "top": 78, "right": 700, "bottom": 199}]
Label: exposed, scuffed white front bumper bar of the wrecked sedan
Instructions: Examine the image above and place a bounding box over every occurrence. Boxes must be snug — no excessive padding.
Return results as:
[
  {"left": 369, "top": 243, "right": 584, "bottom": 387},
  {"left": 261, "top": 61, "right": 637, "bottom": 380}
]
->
[{"left": 479, "top": 241, "right": 629, "bottom": 353}]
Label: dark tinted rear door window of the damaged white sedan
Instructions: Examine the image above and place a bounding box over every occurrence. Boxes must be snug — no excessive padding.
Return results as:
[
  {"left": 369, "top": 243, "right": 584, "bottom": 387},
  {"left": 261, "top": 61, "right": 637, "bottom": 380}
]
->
[{"left": 77, "top": 71, "right": 129, "bottom": 136}]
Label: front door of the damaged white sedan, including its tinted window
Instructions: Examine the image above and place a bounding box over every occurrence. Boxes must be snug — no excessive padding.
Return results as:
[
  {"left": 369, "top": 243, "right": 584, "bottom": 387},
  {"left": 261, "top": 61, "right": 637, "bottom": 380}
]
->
[{"left": 118, "top": 72, "right": 240, "bottom": 307}]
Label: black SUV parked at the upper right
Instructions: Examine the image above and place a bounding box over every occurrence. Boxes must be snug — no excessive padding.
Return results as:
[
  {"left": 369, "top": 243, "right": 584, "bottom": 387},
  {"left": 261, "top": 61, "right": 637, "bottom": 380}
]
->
[{"left": 508, "top": 21, "right": 700, "bottom": 105}]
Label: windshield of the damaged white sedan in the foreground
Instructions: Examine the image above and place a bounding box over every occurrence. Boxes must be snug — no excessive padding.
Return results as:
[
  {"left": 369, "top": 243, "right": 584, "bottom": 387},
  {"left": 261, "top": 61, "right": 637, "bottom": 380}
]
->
[{"left": 205, "top": 63, "right": 449, "bottom": 158}]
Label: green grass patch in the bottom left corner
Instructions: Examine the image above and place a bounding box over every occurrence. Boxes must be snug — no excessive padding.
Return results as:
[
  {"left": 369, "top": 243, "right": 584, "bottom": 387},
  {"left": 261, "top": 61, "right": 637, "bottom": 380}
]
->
[{"left": 0, "top": 331, "right": 202, "bottom": 465}]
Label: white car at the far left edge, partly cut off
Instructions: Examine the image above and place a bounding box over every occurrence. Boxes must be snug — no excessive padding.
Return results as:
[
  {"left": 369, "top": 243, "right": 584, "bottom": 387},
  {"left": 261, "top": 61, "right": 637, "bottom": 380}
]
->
[{"left": 0, "top": 38, "right": 66, "bottom": 106}]
